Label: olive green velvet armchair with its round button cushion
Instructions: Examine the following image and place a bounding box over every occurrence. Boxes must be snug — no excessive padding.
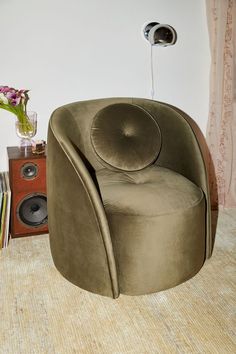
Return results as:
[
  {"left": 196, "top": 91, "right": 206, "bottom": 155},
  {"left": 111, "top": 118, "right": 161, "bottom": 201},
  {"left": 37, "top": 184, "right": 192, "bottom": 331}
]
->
[{"left": 47, "top": 98, "right": 212, "bottom": 298}]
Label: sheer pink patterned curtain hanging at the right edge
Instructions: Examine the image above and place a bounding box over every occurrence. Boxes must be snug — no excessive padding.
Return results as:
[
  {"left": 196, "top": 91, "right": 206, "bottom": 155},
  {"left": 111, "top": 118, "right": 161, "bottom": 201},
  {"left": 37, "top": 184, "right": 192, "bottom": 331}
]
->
[{"left": 206, "top": 0, "right": 236, "bottom": 207}]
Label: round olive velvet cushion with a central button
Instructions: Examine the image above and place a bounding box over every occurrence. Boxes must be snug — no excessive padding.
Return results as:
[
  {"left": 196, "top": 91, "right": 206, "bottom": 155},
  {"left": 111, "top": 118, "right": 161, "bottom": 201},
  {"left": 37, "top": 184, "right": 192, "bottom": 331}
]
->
[{"left": 91, "top": 103, "right": 161, "bottom": 171}]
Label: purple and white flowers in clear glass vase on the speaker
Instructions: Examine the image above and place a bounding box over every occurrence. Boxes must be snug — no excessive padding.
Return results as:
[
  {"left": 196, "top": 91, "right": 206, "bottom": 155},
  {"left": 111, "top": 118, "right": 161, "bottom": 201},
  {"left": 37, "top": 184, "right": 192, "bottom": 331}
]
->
[{"left": 0, "top": 86, "right": 37, "bottom": 146}]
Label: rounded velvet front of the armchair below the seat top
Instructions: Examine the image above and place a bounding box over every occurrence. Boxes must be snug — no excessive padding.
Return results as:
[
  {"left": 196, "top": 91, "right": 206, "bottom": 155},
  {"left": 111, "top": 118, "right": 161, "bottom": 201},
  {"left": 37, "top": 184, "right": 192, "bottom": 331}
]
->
[{"left": 109, "top": 198, "right": 205, "bottom": 295}]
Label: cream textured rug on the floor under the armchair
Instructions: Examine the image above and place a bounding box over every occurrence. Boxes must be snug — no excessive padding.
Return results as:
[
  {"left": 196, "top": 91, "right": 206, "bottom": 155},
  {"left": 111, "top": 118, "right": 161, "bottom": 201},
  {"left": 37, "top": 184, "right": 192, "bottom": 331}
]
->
[{"left": 0, "top": 209, "right": 236, "bottom": 354}]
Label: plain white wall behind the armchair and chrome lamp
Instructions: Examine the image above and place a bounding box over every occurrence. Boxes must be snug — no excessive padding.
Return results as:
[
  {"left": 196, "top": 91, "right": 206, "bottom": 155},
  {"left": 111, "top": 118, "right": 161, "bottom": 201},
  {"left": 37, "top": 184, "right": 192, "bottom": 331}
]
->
[{"left": 0, "top": 0, "right": 210, "bottom": 170}]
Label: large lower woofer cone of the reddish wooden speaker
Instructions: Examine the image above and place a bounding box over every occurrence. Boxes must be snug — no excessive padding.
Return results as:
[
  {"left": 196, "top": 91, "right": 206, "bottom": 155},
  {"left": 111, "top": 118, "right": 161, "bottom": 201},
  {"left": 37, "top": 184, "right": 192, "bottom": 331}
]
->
[{"left": 17, "top": 193, "right": 48, "bottom": 227}]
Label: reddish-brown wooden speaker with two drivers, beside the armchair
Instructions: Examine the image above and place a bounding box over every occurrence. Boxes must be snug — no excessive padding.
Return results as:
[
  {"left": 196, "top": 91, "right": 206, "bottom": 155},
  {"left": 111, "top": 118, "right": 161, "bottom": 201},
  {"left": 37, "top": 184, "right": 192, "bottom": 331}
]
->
[{"left": 7, "top": 147, "right": 48, "bottom": 237}]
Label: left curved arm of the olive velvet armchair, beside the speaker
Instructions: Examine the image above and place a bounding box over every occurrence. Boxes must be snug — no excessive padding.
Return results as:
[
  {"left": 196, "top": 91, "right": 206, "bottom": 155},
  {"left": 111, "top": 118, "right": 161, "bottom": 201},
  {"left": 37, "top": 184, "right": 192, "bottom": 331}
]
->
[{"left": 47, "top": 109, "right": 119, "bottom": 298}]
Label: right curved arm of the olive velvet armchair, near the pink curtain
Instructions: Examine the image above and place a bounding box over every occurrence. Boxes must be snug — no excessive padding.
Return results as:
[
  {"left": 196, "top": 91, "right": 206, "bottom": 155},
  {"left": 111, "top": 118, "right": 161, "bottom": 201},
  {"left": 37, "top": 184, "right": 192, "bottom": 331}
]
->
[{"left": 133, "top": 98, "right": 213, "bottom": 258}]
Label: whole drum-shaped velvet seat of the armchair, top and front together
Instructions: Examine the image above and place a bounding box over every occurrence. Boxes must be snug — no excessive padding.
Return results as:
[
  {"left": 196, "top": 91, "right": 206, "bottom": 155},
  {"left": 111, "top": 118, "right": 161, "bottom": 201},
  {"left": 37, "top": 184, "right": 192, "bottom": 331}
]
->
[{"left": 97, "top": 165, "right": 205, "bottom": 295}]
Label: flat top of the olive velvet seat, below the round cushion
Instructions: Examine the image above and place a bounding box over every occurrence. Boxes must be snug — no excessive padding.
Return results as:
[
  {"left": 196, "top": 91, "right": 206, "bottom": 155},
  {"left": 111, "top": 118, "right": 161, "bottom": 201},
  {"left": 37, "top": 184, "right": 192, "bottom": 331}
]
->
[{"left": 96, "top": 165, "right": 203, "bottom": 216}]
